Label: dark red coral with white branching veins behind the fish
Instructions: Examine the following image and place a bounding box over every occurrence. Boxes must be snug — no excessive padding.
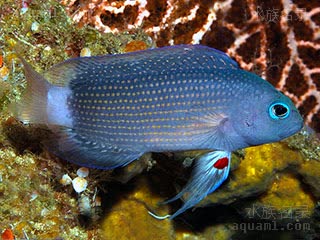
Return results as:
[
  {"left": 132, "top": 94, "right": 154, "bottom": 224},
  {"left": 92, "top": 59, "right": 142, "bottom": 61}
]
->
[{"left": 61, "top": 0, "right": 320, "bottom": 132}]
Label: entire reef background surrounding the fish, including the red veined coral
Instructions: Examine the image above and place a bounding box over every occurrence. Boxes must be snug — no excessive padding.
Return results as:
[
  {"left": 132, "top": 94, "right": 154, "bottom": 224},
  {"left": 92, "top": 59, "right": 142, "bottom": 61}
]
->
[{"left": 0, "top": 0, "right": 320, "bottom": 240}]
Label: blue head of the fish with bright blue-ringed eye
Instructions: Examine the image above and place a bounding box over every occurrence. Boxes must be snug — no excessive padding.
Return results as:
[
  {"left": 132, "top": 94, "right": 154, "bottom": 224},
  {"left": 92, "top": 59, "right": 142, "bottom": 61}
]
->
[{"left": 233, "top": 76, "right": 303, "bottom": 146}]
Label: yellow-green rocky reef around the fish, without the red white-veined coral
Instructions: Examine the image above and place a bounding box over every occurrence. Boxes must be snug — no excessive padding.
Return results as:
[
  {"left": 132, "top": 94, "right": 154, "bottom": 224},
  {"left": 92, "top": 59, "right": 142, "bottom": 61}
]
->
[{"left": 0, "top": 0, "right": 320, "bottom": 240}]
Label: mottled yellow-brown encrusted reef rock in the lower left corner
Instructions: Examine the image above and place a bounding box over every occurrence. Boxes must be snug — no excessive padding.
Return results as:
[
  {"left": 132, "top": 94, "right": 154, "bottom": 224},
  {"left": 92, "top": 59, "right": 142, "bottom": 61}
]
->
[{"left": 0, "top": 117, "right": 88, "bottom": 239}]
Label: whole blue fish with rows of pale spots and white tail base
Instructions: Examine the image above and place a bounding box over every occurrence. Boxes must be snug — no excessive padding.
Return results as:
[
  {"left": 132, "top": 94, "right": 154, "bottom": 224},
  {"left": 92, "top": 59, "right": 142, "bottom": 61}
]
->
[{"left": 14, "top": 45, "right": 303, "bottom": 219}]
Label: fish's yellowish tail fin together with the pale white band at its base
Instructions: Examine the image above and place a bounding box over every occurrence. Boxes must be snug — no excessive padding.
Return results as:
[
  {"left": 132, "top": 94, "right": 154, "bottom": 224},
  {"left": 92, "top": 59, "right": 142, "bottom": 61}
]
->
[{"left": 9, "top": 57, "right": 72, "bottom": 127}]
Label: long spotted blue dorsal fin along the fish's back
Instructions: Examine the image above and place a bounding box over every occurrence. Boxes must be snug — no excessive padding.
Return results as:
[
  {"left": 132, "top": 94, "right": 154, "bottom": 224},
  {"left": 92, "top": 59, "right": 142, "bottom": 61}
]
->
[{"left": 44, "top": 45, "right": 238, "bottom": 86}]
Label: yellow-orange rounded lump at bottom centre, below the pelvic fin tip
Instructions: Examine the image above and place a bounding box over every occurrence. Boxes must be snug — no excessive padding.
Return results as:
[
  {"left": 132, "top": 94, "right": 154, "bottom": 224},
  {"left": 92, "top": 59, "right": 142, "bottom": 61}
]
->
[{"left": 102, "top": 178, "right": 175, "bottom": 240}]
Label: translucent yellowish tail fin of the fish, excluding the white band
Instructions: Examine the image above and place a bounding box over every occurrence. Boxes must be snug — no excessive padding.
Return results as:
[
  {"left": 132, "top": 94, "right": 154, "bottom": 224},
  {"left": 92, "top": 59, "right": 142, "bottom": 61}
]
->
[{"left": 9, "top": 57, "right": 51, "bottom": 124}]
